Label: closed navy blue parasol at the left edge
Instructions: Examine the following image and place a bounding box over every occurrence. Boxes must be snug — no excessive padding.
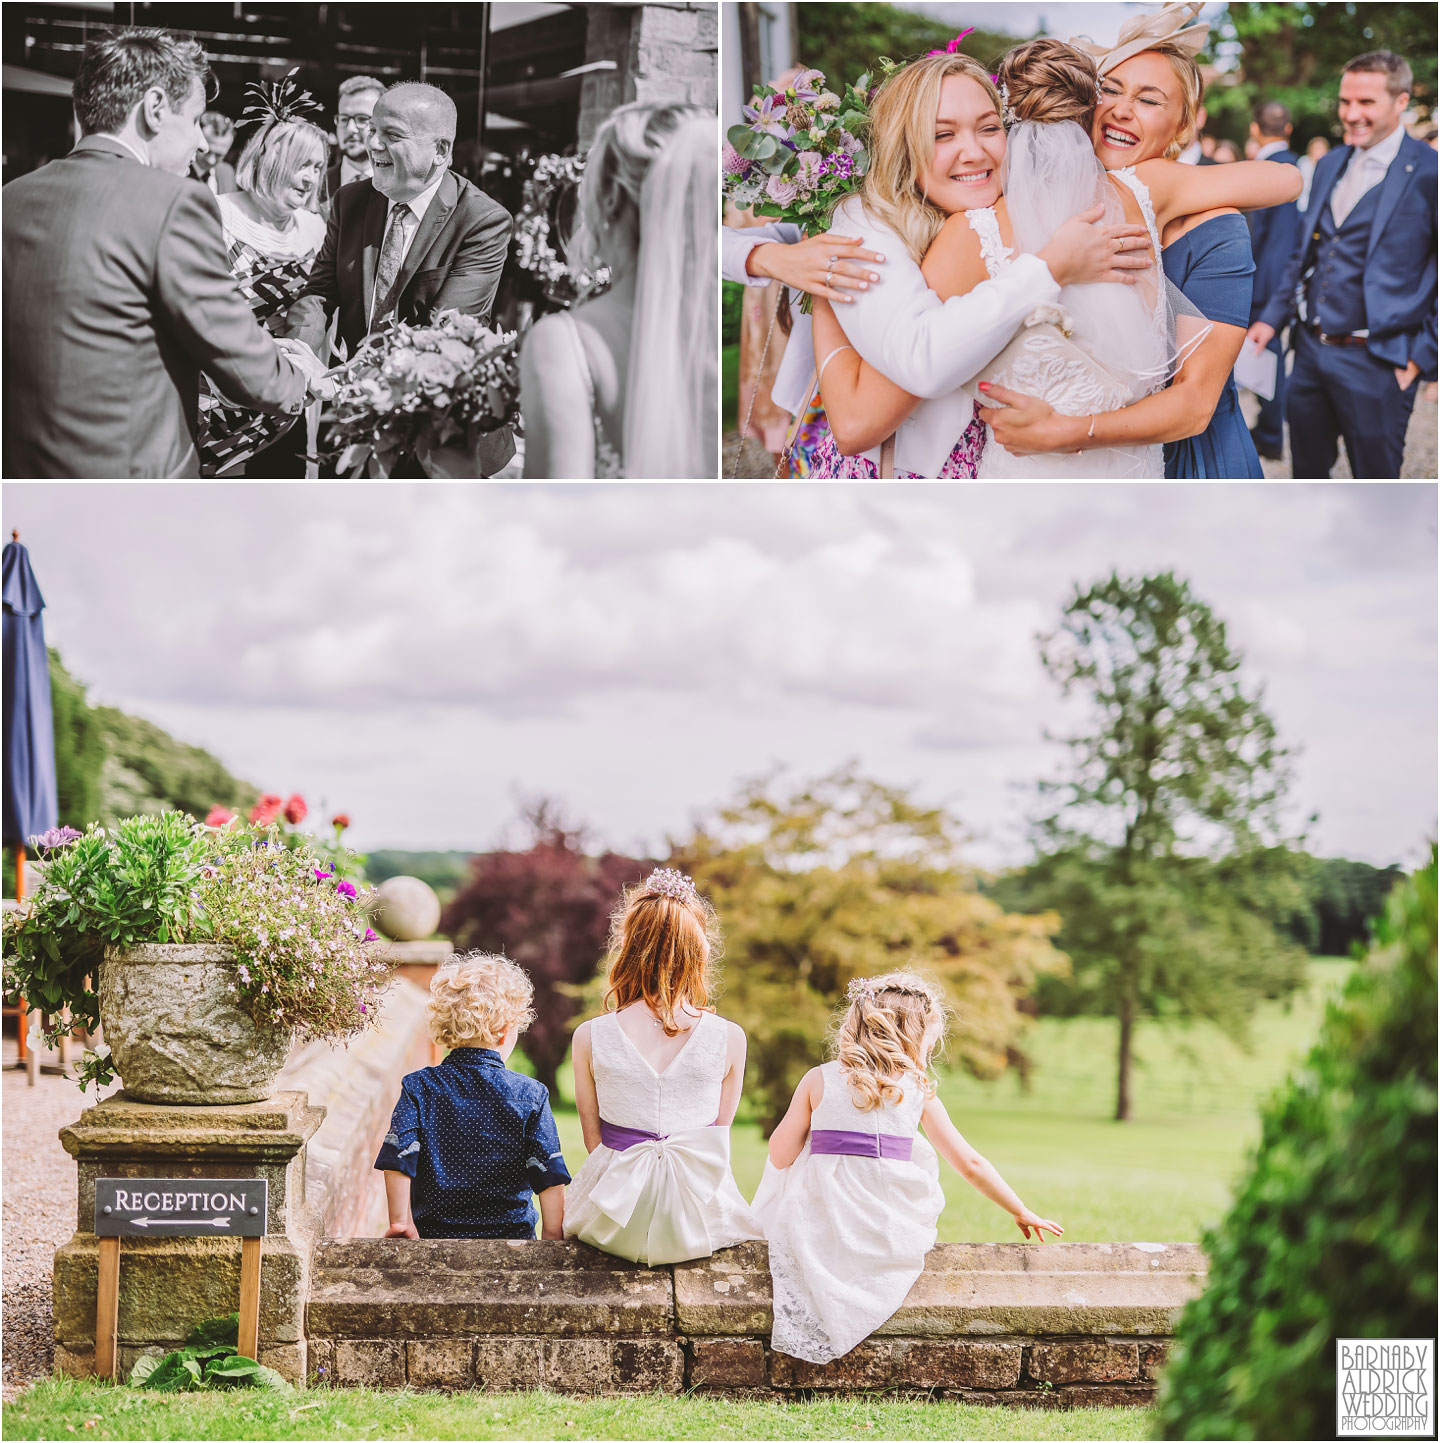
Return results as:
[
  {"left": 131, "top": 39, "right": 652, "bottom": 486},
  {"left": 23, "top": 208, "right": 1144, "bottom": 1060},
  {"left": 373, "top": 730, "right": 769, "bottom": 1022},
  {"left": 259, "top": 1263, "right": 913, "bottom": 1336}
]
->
[{"left": 3, "top": 531, "right": 59, "bottom": 847}]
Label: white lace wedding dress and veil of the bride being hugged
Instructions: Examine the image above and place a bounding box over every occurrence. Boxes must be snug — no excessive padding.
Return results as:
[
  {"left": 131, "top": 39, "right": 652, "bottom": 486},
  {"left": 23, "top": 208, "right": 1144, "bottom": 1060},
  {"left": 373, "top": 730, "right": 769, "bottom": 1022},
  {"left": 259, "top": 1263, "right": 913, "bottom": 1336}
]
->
[{"left": 965, "top": 121, "right": 1193, "bottom": 481}]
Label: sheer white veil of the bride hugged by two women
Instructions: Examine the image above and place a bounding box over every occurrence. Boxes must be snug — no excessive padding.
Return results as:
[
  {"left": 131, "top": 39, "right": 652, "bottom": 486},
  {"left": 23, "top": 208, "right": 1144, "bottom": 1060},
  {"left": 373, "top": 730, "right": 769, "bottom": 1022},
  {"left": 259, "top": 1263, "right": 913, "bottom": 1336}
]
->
[{"left": 1001, "top": 120, "right": 1206, "bottom": 398}]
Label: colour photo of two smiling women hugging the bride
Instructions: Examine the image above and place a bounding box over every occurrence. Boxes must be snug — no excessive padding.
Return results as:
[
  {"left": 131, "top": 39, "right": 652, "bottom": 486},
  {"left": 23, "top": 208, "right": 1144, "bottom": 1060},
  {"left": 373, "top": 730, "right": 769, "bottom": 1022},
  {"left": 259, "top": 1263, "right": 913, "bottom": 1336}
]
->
[{"left": 721, "top": 0, "right": 1437, "bottom": 481}]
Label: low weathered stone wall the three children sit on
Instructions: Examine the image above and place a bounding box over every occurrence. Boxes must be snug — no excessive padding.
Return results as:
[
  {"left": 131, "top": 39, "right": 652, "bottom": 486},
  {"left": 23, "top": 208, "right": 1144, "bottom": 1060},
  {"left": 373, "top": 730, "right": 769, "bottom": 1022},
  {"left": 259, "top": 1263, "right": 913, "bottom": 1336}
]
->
[{"left": 306, "top": 1238, "right": 1205, "bottom": 1408}]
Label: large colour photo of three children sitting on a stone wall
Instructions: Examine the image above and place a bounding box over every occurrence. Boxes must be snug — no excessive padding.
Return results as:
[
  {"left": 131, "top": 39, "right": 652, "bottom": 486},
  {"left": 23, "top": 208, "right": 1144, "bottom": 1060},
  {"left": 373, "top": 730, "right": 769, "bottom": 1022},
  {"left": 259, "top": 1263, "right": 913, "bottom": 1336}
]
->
[{"left": 3, "top": 482, "right": 1437, "bottom": 1439}]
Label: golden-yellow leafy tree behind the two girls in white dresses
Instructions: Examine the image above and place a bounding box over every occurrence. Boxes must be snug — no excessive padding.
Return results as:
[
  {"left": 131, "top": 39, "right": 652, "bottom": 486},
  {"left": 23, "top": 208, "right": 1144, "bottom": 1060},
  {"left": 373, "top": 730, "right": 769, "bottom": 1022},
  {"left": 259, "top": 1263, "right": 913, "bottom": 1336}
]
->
[{"left": 671, "top": 771, "right": 1065, "bottom": 1133}]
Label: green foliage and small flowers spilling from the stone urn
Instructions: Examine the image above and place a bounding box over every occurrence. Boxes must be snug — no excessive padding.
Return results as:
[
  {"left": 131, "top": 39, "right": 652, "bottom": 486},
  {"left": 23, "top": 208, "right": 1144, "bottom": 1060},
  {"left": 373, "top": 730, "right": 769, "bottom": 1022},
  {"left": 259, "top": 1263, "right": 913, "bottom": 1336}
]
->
[{"left": 3, "top": 811, "right": 390, "bottom": 1088}]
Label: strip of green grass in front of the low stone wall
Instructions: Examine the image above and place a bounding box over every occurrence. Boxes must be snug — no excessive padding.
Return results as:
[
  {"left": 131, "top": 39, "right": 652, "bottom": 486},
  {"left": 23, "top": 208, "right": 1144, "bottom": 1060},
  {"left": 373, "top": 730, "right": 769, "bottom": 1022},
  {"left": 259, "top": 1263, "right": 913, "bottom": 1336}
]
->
[{"left": 4, "top": 1380, "right": 1154, "bottom": 1439}]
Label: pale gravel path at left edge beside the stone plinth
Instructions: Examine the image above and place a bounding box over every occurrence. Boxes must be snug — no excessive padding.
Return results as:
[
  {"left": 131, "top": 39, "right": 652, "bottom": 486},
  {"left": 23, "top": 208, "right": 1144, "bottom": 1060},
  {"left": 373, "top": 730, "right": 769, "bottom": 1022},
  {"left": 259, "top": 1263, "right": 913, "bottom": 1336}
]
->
[{"left": 0, "top": 1038, "right": 114, "bottom": 1403}]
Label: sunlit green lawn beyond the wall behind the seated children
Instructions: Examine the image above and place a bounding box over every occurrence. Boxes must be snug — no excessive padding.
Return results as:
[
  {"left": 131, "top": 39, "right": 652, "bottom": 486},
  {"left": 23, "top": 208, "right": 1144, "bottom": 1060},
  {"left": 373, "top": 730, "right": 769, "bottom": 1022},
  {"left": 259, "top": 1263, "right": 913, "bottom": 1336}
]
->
[{"left": 556, "top": 958, "right": 1355, "bottom": 1242}]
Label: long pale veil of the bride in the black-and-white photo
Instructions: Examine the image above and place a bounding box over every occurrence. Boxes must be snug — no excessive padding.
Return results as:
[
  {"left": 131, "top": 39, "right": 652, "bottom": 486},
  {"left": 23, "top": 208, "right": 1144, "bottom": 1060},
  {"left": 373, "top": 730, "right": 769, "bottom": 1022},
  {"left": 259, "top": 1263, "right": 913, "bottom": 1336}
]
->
[{"left": 625, "top": 114, "right": 720, "bottom": 479}]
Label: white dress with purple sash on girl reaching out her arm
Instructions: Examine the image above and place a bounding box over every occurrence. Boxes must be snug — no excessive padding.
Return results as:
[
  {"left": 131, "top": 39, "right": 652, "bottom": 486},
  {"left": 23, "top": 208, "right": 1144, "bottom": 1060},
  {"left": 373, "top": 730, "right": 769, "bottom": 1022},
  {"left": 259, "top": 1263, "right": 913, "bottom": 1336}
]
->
[{"left": 755, "top": 1062, "right": 945, "bottom": 1362}]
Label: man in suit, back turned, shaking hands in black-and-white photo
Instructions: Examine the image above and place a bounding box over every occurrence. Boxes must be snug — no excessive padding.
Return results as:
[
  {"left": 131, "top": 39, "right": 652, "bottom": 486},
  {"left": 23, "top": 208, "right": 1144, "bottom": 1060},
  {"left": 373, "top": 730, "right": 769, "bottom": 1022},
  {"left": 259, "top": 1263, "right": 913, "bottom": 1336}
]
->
[{"left": 3, "top": 29, "right": 325, "bottom": 478}]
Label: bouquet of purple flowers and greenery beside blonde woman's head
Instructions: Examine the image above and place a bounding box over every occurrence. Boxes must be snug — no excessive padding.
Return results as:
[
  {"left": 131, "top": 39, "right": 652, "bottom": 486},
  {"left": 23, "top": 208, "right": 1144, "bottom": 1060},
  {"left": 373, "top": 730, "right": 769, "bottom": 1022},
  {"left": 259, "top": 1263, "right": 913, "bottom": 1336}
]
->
[{"left": 721, "top": 71, "right": 870, "bottom": 236}]
